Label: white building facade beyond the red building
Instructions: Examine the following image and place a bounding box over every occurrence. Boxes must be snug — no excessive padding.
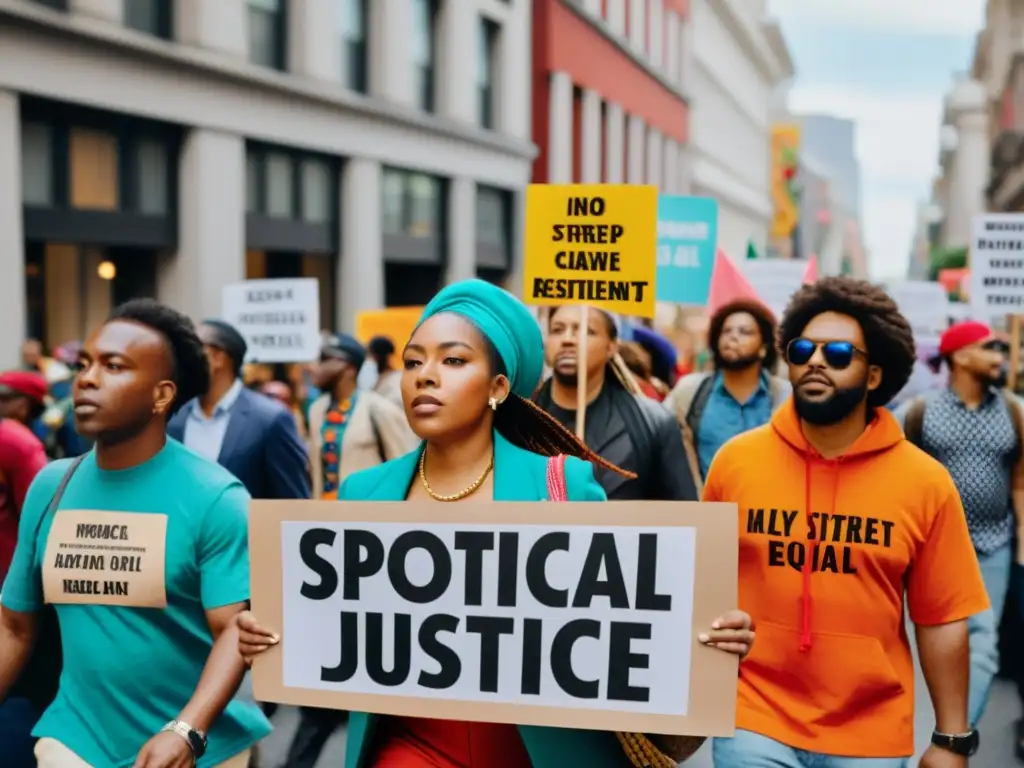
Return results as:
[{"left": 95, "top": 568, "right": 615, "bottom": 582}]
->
[{"left": 688, "top": 0, "right": 794, "bottom": 258}]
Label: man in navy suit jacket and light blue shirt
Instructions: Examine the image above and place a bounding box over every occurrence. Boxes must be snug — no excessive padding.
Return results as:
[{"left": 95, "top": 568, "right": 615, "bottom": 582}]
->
[{"left": 167, "top": 319, "right": 310, "bottom": 499}]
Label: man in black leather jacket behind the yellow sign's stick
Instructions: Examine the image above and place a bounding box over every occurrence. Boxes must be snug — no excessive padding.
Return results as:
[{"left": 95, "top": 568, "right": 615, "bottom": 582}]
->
[{"left": 534, "top": 305, "right": 697, "bottom": 501}]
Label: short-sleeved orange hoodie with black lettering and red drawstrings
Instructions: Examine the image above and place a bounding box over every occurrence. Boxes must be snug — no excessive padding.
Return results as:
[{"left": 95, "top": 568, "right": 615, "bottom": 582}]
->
[{"left": 705, "top": 399, "right": 988, "bottom": 758}]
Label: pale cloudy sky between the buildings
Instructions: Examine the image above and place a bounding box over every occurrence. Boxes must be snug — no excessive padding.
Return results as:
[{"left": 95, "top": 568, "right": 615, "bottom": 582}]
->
[{"left": 769, "top": 0, "right": 985, "bottom": 280}]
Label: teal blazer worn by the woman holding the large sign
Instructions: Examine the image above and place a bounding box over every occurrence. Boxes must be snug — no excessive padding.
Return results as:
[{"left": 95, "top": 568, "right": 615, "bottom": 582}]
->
[{"left": 338, "top": 432, "right": 629, "bottom": 768}]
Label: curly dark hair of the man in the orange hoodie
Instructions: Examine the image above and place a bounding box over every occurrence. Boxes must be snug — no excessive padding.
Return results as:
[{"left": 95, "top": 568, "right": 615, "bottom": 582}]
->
[{"left": 778, "top": 278, "right": 916, "bottom": 408}]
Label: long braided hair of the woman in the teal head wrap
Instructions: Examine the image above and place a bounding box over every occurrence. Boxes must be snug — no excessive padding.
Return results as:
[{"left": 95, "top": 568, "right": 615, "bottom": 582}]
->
[{"left": 481, "top": 334, "right": 636, "bottom": 480}]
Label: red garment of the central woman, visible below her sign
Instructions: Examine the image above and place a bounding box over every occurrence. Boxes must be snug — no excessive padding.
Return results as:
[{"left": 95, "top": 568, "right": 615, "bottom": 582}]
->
[{"left": 370, "top": 717, "right": 530, "bottom": 768}]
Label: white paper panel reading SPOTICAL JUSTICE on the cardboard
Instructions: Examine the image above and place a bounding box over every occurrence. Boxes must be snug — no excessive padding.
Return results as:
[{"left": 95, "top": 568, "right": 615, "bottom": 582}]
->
[{"left": 281, "top": 522, "right": 696, "bottom": 716}]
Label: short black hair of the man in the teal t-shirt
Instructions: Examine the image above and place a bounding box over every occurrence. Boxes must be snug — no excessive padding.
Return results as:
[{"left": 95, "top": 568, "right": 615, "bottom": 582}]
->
[{"left": 106, "top": 299, "right": 210, "bottom": 417}]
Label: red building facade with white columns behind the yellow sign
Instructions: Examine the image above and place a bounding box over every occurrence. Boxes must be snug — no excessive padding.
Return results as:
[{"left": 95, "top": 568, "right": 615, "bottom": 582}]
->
[{"left": 532, "top": 0, "right": 692, "bottom": 194}]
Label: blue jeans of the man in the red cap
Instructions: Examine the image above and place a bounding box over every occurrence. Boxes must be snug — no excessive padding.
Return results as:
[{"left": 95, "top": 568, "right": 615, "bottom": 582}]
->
[{"left": 967, "top": 544, "right": 1014, "bottom": 725}]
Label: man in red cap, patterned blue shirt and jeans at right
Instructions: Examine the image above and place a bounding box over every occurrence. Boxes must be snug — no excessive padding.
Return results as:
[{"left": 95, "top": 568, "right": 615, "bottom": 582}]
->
[{"left": 896, "top": 322, "right": 1024, "bottom": 725}]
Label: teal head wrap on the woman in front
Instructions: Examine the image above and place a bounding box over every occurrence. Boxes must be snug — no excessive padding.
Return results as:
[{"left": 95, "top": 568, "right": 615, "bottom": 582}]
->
[{"left": 417, "top": 280, "right": 544, "bottom": 398}]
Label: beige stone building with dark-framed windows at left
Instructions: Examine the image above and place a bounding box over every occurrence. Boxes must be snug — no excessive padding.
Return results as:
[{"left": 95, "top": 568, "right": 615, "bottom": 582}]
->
[{"left": 0, "top": 0, "right": 535, "bottom": 366}]
